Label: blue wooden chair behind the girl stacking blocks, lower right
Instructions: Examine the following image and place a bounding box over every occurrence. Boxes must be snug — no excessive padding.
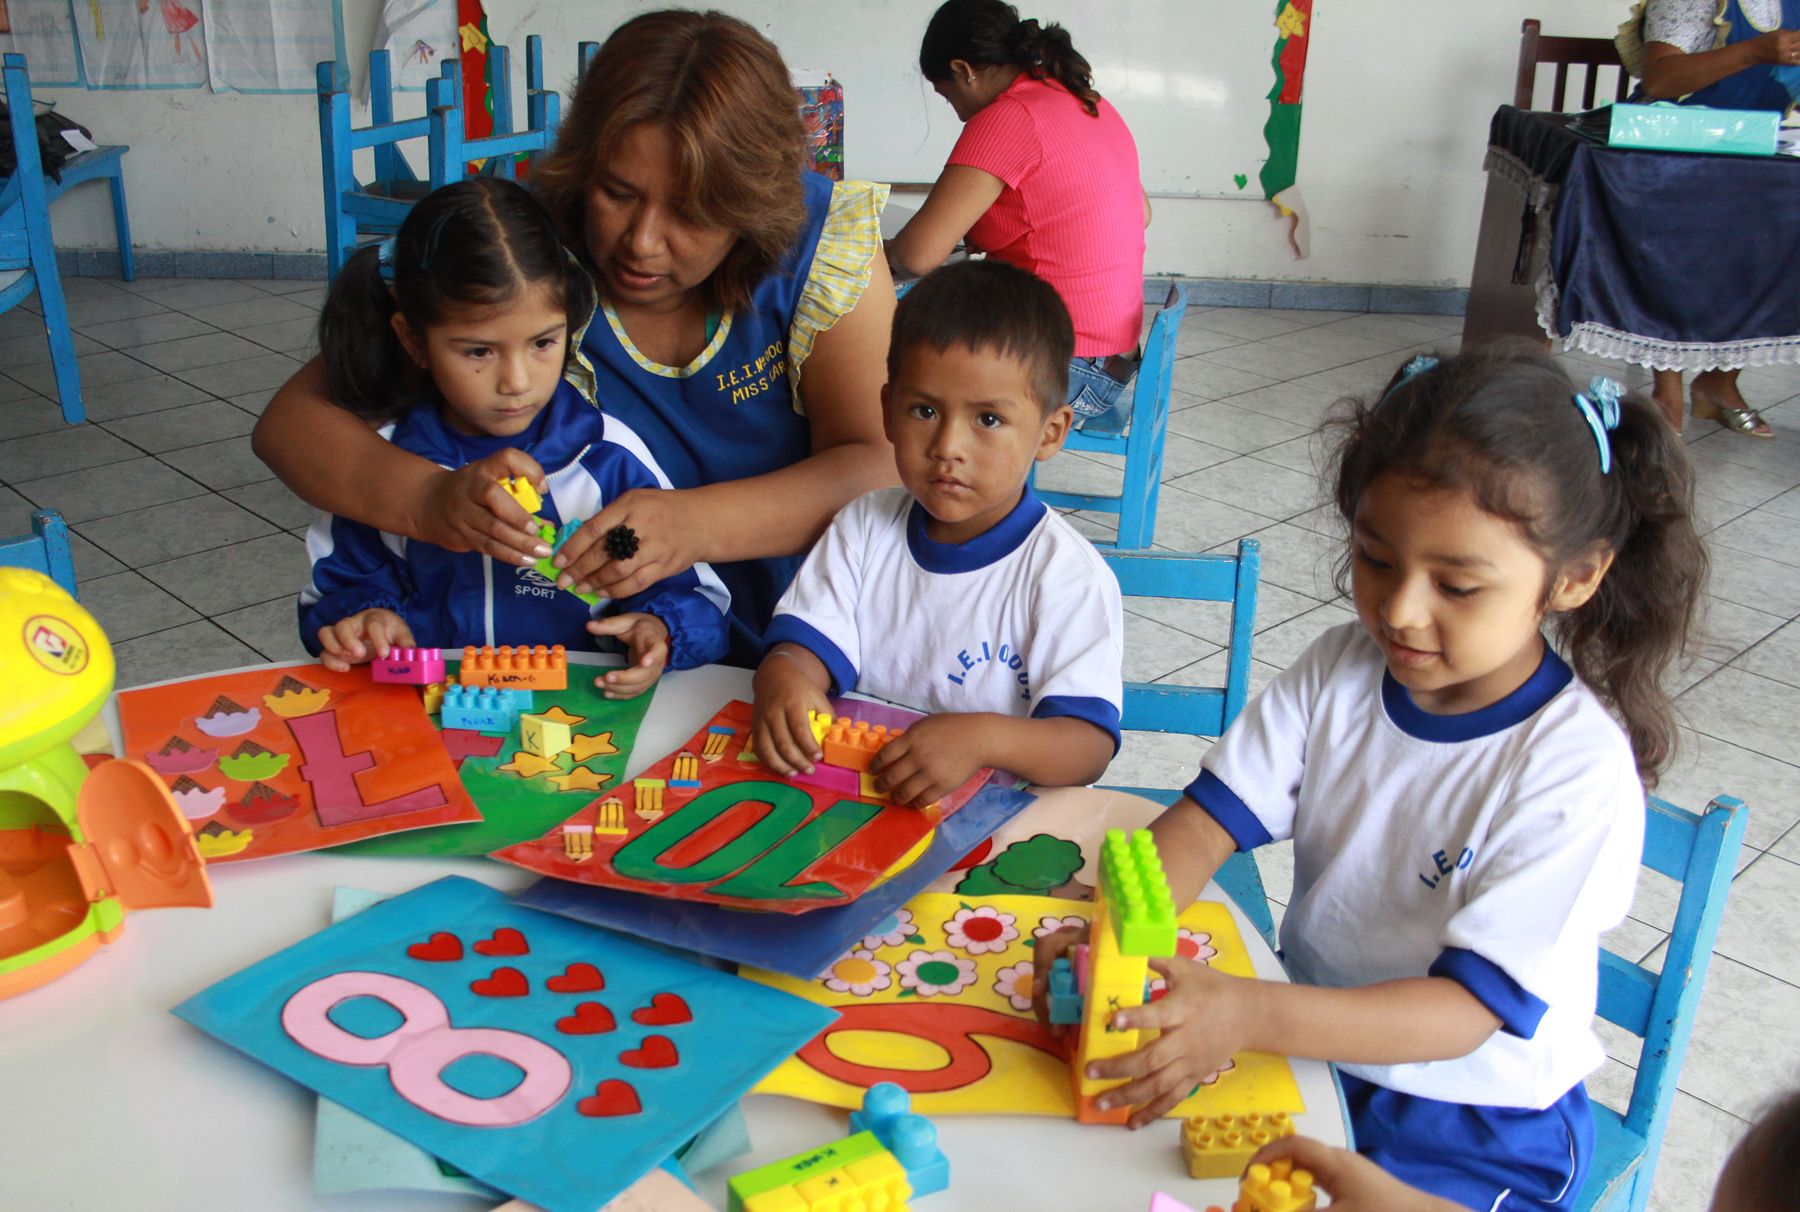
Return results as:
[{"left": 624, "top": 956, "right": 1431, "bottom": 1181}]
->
[{"left": 1575, "top": 796, "right": 1750, "bottom": 1212}]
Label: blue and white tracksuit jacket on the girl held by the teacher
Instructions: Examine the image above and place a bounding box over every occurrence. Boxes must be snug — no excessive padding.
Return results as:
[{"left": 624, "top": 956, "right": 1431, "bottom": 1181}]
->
[{"left": 299, "top": 382, "right": 731, "bottom": 670}]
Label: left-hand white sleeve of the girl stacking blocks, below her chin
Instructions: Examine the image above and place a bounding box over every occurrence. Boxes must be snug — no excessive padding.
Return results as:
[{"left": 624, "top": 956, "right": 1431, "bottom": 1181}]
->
[{"left": 1184, "top": 623, "right": 1357, "bottom": 850}]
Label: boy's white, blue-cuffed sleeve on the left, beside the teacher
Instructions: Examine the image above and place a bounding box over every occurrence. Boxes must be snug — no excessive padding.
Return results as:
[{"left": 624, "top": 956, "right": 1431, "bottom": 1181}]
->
[{"left": 763, "top": 497, "right": 871, "bottom": 695}]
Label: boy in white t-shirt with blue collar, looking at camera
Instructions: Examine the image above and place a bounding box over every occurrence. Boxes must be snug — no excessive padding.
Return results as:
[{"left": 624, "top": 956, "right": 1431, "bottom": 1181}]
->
[{"left": 754, "top": 261, "right": 1123, "bottom": 805}]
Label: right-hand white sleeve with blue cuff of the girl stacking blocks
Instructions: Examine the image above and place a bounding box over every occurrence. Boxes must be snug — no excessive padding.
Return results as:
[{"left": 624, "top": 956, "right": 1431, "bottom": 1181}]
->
[{"left": 1431, "top": 729, "right": 1643, "bottom": 1039}]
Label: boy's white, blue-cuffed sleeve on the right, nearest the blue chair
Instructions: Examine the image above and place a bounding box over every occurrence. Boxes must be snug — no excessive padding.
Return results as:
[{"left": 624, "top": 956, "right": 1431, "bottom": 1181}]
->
[{"left": 1026, "top": 538, "right": 1125, "bottom": 753}]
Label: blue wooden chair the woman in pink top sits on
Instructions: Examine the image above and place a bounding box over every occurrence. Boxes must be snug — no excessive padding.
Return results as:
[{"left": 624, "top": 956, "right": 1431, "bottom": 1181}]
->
[{"left": 1037, "top": 283, "right": 1188, "bottom": 551}]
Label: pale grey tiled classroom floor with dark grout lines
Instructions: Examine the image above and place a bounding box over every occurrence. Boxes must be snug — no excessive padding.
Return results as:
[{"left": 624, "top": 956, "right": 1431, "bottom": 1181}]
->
[{"left": 0, "top": 279, "right": 1800, "bottom": 1210}]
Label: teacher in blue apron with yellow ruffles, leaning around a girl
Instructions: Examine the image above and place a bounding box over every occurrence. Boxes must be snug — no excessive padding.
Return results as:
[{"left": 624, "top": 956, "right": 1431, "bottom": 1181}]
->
[{"left": 252, "top": 11, "right": 895, "bottom": 665}]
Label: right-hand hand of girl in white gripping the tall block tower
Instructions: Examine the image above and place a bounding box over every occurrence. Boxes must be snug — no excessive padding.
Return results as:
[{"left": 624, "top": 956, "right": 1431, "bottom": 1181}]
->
[{"left": 1087, "top": 960, "right": 1260, "bottom": 1129}]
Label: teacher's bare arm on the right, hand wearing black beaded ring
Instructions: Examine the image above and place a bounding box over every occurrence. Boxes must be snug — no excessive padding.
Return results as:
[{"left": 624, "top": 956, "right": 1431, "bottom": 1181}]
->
[{"left": 556, "top": 258, "right": 900, "bottom": 598}]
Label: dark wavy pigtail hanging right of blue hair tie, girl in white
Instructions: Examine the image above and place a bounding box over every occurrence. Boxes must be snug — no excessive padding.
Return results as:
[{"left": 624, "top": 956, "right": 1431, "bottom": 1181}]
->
[{"left": 1555, "top": 396, "right": 1708, "bottom": 787}]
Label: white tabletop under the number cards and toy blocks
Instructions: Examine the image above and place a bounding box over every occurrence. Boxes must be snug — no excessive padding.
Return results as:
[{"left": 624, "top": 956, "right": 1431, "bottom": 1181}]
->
[{"left": 0, "top": 666, "right": 1345, "bottom": 1212}]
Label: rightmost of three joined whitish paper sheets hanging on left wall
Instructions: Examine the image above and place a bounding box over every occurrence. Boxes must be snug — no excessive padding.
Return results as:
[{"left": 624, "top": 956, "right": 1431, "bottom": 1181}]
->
[{"left": 205, "top": 0, "right": 344, "bottom": 92}]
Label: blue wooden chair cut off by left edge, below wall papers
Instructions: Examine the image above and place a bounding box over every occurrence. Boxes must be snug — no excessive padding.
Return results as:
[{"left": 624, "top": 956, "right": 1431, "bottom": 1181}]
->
[{"left": 0, "top": 54, "right": 88, "bottom": 425}]
